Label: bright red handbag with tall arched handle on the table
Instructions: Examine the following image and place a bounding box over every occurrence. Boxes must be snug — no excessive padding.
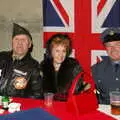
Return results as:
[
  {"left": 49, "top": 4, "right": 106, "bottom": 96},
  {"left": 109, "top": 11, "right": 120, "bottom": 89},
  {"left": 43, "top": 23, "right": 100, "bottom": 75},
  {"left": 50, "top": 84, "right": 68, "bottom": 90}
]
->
[{"left": 67, "top": 72, "right": 98, "bottom": 116}]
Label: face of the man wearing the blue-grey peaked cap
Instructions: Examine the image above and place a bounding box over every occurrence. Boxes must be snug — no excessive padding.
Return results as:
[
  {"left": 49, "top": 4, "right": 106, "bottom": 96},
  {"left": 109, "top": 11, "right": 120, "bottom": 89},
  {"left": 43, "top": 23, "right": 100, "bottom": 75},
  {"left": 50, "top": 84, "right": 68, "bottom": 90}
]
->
[{"left": 105, "top": 41, "right": 120, "bottom": 61}]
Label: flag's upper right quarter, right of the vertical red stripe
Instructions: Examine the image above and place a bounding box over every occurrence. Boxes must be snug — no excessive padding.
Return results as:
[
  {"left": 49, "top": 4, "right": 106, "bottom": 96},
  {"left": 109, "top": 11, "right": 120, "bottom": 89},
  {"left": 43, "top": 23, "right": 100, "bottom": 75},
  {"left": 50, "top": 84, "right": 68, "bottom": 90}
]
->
[{"left": 92, "top": 0, "right": 120, "bottom": 33}]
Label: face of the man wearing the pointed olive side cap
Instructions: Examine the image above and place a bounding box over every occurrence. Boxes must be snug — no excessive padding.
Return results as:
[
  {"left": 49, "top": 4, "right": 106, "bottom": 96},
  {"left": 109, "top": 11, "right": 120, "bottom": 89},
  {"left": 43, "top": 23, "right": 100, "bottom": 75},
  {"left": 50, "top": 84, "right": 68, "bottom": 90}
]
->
[{"left": 12, "top": 34, "right": 31, "bottom": 56}]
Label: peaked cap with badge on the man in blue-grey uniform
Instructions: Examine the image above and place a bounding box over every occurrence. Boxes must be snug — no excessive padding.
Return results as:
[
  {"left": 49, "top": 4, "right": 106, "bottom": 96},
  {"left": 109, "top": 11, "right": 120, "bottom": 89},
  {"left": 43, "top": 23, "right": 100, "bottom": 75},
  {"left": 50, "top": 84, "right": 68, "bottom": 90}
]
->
[{"left": 101, "top": 28, "right": 120, "bottom": 44}]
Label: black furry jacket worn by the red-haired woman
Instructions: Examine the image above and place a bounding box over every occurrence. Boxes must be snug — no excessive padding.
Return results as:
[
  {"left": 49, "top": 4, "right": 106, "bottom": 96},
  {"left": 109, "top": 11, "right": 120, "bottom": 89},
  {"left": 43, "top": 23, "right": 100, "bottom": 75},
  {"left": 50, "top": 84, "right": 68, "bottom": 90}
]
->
[{"left": 41, "top": 58, "right": 82, "bottom": 99}]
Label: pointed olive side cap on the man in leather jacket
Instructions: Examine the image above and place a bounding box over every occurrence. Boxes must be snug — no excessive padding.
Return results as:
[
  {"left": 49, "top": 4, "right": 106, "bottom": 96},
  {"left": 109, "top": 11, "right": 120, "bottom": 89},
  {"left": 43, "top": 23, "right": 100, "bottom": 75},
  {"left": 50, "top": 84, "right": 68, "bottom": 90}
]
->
[{"left": 12, "top": 23, "right": 32, "bottom": 40}]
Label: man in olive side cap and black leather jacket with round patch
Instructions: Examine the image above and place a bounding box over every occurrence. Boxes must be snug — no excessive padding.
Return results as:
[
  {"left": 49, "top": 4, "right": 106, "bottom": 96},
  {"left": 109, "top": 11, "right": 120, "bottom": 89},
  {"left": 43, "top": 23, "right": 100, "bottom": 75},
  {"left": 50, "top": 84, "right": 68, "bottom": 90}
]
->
[{"left": 0, "top": 23, "right": 41, "bottom": 98}]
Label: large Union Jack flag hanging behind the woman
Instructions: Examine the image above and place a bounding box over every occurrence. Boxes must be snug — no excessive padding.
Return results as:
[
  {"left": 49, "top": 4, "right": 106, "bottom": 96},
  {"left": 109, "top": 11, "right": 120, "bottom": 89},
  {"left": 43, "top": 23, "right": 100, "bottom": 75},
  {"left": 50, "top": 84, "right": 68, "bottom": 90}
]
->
[{"left": 43, "top": 0, "right": 120, "bottom": 71}]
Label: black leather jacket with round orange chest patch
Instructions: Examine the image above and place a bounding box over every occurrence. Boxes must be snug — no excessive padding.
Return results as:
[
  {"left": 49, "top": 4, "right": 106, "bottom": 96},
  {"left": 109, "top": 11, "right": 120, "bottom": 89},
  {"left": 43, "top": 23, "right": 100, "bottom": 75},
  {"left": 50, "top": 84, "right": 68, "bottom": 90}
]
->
[{"left": 0, "top": 52, "right": 41, "bottom": 98}]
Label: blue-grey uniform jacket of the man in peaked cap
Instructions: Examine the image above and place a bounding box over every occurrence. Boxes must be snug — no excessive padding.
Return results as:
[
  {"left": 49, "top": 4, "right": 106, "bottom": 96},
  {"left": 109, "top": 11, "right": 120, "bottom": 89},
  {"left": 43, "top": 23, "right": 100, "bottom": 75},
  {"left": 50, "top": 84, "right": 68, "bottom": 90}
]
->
[{"left": 92, "top": 57, "right": 120, "bottom": 104}]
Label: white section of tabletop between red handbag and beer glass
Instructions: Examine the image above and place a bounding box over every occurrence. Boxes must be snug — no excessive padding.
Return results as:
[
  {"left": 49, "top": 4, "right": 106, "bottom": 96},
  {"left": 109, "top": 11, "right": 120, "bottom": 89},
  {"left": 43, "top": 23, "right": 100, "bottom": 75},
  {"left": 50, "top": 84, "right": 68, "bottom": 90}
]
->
[{"left": 98, "top": 105, "right": 120, "bottom": 120}]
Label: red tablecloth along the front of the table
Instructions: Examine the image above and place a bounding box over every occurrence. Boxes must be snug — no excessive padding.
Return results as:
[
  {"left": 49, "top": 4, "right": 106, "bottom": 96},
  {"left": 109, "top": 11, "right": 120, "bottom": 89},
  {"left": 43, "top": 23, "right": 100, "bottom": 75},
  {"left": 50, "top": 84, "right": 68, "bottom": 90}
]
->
[{"left": 0, "top": 98, "right": 116, "bottom": 120}]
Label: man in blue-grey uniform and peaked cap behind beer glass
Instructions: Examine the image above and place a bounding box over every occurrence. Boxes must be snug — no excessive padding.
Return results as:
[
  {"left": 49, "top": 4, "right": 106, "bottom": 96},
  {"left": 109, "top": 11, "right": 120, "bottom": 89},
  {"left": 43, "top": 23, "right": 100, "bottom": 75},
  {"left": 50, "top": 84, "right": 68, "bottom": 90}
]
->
[{"left": 92, "top": 28, "right": 120, "bottom": 104}]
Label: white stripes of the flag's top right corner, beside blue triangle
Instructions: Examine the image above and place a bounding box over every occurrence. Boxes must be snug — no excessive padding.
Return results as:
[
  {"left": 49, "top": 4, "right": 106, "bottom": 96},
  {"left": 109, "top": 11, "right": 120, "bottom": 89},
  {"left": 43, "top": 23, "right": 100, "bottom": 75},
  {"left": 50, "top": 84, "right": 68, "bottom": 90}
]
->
[{"left": 91, "top": 0, "right": 116, "bottom": 33}]
